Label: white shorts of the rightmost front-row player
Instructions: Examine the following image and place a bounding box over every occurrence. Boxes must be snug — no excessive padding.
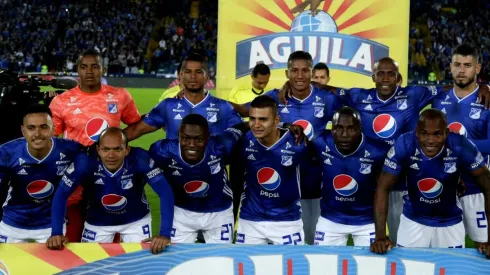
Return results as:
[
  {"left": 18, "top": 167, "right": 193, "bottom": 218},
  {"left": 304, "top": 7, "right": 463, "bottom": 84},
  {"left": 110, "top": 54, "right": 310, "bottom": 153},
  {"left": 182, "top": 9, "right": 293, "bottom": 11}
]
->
[{"left": 397, "top": 215, "right": 465, "bottom": 248}]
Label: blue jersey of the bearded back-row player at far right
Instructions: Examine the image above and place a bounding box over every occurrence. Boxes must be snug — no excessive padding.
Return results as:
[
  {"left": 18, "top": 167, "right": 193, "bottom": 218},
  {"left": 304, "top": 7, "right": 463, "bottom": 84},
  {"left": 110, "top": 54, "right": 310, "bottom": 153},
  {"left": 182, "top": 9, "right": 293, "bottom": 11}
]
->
[{"left": 432, "top": 88, "right": 490, "bottom": 195}]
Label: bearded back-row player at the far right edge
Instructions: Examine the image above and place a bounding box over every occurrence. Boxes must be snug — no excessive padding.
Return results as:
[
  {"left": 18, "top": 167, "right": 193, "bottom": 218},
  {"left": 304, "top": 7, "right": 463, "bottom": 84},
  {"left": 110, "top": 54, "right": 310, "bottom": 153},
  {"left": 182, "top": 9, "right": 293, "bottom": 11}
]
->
[{"left": 432, "top": 44, "right": 490, "bottom": 248}]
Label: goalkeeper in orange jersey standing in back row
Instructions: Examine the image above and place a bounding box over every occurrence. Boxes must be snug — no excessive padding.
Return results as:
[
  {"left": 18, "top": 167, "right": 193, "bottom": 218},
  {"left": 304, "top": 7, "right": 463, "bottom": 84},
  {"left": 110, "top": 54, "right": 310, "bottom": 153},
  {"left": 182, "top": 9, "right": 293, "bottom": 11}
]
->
[{"left": 49, "top": 50, "right": 141, "bottom": 242}]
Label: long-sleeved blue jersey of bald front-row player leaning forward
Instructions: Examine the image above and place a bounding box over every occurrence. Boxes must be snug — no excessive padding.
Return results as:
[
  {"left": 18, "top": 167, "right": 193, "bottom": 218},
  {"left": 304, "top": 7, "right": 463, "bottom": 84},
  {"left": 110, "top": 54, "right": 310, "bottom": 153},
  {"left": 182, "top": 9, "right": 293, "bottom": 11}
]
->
[{"left": 52, "top": 147, "right": 174, "bottom": 237}]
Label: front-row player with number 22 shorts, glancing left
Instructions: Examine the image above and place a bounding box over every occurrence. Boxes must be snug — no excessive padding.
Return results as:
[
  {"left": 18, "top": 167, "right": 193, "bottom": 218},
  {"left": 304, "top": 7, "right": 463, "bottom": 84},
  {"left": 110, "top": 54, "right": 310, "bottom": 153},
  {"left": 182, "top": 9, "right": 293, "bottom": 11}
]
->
[{"left": 236, "top": 95, "right": 306, "bottom": 245}]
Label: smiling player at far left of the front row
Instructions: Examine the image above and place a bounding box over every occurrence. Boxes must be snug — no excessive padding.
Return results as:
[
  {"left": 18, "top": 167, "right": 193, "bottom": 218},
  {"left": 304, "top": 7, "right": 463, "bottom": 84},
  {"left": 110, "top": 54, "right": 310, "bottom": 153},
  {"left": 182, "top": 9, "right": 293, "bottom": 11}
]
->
[{"left": 0, "top": 105, "right": 82, "bottom": 243}]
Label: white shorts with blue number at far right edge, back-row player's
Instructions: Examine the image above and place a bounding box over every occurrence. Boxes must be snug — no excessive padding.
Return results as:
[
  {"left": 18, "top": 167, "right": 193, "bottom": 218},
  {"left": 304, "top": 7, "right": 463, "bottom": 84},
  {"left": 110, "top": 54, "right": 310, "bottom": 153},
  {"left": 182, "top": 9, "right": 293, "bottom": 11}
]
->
[{"left": 459, "top": 193, "right": 488, "bottom": 243}]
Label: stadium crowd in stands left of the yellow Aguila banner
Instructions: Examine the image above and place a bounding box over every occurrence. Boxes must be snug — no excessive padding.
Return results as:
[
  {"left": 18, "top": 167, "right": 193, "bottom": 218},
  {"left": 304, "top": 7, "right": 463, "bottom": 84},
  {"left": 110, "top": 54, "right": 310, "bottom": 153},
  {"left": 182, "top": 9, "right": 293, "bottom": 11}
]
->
[{"left": 0, "top": 0, "right": 217, "bottom": 73}]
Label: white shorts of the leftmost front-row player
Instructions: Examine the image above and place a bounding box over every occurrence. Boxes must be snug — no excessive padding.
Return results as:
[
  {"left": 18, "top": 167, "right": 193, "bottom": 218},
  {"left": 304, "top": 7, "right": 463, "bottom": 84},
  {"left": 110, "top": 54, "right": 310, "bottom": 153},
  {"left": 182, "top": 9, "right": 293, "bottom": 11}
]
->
[{"left": 0, "top": 221, "right": 66, "bottom": 243}]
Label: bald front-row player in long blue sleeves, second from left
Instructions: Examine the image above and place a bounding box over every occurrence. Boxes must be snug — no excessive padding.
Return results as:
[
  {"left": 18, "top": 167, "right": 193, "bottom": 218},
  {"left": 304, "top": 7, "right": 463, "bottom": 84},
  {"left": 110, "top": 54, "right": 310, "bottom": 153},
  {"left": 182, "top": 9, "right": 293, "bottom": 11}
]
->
[{"left": 47, "top": 127, "right": 174, "bottom": 253}]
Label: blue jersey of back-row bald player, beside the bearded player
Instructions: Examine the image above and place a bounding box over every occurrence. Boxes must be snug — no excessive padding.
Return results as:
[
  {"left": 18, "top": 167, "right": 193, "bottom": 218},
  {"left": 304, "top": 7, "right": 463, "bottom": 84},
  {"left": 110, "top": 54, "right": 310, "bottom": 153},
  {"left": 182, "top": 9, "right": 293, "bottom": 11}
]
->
[{"left": 338, "top": 86, "right": 442, "bottom": 145}]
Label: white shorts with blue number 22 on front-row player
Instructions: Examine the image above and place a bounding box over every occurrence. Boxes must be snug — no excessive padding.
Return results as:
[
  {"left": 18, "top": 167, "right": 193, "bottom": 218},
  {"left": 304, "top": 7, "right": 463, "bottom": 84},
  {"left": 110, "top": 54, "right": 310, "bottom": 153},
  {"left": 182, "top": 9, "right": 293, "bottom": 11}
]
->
[{"left": 236, "top": 219, "right": 305, "bottom": 245}]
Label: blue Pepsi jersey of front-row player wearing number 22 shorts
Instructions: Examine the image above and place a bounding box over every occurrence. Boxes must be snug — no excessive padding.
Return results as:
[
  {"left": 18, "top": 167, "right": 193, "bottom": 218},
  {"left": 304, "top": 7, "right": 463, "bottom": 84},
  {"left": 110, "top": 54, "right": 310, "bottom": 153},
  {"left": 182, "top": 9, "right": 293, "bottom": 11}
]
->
[{"left": 240, "top": 132, "right": 307, "bottom": 221}]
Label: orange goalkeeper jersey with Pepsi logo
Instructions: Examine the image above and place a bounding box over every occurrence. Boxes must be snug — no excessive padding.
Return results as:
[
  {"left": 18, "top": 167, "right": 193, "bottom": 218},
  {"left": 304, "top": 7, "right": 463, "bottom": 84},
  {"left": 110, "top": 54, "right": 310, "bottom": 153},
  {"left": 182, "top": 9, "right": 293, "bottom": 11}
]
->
[{"left": 49, "top": 85, "right": 141, "bottom": 146}]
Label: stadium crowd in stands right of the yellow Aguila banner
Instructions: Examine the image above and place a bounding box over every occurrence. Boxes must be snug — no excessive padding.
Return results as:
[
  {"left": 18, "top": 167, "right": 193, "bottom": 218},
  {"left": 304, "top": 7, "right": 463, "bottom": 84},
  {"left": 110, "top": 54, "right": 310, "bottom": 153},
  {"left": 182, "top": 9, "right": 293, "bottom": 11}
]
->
[{"left": 409, "top": 0, "right": 490, "bottom": 82}]
